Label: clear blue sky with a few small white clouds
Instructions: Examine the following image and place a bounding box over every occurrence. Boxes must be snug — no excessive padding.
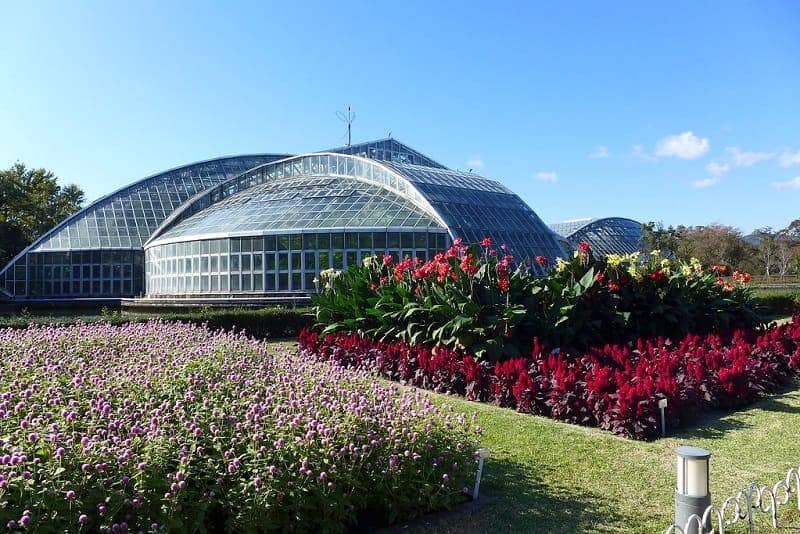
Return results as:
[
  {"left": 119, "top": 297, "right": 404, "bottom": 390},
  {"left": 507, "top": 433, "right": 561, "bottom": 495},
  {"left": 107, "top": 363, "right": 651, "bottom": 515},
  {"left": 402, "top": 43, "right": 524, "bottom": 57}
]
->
[{"left": 0, "top": 1, "right": 800, "bottom": 232}]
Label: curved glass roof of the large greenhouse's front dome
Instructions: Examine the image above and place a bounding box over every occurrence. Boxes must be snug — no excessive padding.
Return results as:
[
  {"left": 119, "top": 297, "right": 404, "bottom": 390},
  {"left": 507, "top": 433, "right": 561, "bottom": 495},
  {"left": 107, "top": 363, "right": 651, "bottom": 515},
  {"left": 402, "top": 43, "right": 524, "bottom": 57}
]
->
[{"left": 147, "top": 153, "right": 564, "bottom": 274}]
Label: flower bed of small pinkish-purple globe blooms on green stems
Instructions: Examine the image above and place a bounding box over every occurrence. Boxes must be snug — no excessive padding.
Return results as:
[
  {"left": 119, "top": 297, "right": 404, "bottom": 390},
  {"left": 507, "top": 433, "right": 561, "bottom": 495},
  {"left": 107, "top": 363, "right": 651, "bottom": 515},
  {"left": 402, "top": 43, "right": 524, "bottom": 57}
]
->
[{"left": 0, "top": 322, "right": 477, "bottom": 532}]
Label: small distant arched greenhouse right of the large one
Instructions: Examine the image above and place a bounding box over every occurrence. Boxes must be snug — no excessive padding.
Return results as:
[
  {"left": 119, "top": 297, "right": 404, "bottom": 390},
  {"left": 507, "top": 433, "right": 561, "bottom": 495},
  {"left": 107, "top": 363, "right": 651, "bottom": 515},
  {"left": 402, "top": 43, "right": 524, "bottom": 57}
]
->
[{"left": 550, "top": 217, "right": 642, "bottom": 256}]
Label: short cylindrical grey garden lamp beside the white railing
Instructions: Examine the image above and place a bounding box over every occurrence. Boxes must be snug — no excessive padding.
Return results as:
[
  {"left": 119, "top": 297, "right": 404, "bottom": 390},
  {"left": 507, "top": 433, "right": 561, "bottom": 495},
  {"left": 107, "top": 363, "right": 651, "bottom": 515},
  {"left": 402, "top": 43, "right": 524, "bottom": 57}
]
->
[{"left": 675, "top": 447, "right": 711, "bottom": 534}]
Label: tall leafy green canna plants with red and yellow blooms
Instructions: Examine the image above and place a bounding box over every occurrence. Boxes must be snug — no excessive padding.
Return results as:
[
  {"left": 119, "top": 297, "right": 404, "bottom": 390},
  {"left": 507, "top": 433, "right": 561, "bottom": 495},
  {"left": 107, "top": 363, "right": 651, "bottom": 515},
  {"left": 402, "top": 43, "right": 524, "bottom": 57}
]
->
[{"left": 314, "top": 238, "right": 763, "bottom": 361}]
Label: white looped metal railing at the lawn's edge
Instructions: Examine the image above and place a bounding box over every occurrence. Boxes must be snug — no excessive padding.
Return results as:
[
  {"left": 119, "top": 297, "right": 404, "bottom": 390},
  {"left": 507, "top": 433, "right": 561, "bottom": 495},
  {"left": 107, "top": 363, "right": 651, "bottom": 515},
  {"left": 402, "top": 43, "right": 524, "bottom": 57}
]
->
[{"left": 664, "top": 467, "right": 800, "bottom": 534}]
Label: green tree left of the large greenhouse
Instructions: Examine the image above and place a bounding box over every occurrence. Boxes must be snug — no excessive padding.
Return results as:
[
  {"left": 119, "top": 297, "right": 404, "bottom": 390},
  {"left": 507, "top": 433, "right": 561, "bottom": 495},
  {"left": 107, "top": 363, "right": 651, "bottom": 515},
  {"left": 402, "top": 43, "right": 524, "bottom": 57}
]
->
[{"left": 0, "top": 162, "right": 84, "bottom": 268}]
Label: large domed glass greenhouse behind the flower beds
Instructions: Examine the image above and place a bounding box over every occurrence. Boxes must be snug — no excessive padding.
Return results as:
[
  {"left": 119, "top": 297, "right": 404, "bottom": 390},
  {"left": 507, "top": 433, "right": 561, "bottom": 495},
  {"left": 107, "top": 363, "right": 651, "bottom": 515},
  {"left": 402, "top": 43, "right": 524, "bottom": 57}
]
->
[{"left": 0, "top": 139, "right": 564, "bottom": 300}]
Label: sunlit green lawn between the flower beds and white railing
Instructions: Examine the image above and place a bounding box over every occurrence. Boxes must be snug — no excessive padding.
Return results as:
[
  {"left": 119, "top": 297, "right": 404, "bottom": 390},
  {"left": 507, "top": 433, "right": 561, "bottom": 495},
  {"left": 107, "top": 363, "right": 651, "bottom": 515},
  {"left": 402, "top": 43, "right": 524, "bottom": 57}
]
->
[{"left": 382, "top": 390, "right": 800, "bottom": 533}]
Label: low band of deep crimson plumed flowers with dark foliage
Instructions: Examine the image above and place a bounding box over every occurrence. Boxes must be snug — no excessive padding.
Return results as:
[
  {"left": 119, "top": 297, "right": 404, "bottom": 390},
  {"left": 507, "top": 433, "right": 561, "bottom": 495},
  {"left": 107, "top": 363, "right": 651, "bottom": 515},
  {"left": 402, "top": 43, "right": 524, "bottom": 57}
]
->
[{"left": 299, "top": 316, "right": 800, "bottom": 439}]
